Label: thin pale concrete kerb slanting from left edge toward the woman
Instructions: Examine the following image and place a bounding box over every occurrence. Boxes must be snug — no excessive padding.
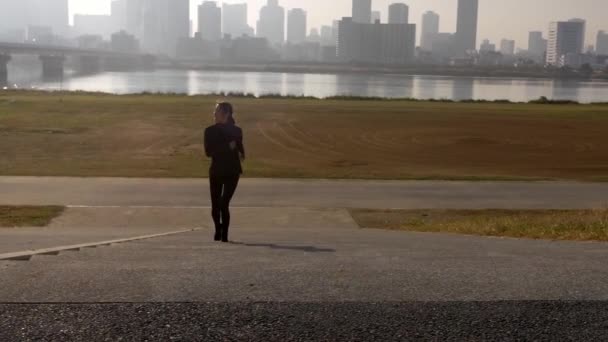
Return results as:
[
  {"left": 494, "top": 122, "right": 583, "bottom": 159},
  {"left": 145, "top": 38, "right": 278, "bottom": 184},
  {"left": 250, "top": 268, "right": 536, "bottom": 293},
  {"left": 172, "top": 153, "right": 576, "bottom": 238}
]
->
[{"left": 0, "top": 228, "right": 201, "bottom": 261}]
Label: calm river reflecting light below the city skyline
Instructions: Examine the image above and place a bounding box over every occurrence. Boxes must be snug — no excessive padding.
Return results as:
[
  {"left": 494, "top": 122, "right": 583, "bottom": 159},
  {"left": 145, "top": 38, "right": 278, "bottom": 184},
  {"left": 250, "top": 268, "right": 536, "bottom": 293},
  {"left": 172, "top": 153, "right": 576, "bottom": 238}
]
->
[{"left": 4, "top": 70, "right": 608, "bottom": 103}]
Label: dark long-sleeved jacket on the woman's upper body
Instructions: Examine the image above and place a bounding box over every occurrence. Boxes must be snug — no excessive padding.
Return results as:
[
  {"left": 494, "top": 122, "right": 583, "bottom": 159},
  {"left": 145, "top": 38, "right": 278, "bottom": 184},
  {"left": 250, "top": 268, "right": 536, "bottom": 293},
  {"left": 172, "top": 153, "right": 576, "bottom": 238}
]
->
[{"left": 205, "top": 124, "right": 244, "bottom": 177}]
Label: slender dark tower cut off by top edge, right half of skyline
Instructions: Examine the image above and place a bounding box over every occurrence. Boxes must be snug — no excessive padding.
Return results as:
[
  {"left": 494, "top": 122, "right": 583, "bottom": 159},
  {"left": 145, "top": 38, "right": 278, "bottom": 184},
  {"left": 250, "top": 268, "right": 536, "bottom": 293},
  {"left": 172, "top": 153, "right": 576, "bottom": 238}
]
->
[{"left": 455, "top": 0, "right": 479, "bottom": 57}]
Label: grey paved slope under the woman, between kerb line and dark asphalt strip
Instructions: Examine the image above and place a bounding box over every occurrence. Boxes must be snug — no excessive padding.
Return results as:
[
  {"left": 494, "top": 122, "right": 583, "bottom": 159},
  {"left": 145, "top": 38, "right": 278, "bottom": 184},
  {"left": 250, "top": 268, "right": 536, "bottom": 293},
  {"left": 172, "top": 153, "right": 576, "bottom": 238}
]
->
[{"left": 0, "top": 208, "right": 608, "bottom": 302}]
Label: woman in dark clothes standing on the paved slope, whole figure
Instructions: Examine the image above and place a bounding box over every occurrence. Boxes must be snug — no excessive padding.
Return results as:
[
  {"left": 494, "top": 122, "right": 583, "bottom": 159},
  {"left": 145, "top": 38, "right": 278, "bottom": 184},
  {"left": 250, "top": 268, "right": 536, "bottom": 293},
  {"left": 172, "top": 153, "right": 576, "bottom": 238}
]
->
[{"left": 205, "top": 102, "right": 245, "bottom": 242}]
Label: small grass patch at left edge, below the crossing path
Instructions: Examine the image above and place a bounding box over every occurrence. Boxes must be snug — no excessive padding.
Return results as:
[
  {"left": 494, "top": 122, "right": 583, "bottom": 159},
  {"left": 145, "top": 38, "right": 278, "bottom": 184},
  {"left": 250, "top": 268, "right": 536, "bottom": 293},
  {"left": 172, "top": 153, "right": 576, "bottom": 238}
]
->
[{"left": 0, "top": 206, "right": 64, "bottom": 228}]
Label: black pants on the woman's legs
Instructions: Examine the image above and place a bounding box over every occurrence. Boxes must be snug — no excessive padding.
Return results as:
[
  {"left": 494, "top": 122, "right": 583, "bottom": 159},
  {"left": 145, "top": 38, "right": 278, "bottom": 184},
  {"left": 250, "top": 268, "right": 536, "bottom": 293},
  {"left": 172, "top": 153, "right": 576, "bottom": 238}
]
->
[{"left": 209, "top": 175, "right": 240, "bottom": 240}]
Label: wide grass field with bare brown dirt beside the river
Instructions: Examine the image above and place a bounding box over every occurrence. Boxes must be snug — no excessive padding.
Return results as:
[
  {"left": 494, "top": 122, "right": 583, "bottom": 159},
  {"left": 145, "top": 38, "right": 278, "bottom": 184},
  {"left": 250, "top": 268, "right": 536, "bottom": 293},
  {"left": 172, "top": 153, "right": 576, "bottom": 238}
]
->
[{"left": 0, "top": 91, "right": 608, "bottom": 181}]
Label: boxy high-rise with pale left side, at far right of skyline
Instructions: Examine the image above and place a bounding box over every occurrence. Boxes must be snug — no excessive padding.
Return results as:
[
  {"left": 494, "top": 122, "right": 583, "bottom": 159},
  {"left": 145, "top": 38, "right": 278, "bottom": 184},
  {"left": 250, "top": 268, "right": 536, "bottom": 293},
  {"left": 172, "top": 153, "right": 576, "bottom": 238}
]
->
[{"left": 547, "top": 19, "right": 585, "bottom": 65}]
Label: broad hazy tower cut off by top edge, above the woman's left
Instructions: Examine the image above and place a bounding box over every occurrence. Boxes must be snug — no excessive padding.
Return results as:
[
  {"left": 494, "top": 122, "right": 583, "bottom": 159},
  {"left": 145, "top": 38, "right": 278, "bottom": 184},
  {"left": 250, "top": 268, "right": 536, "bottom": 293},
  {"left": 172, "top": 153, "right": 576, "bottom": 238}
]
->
[{"left": 143, "top": 0, "right": 190, "bottom": 56}]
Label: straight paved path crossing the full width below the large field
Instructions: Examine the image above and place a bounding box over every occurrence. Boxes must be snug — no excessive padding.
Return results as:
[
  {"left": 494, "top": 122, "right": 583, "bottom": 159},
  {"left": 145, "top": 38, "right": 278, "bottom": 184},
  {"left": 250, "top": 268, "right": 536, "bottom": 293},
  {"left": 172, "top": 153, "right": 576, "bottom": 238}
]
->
[{"left": 0, "top": 177, "right": 608, "bottom": 209}]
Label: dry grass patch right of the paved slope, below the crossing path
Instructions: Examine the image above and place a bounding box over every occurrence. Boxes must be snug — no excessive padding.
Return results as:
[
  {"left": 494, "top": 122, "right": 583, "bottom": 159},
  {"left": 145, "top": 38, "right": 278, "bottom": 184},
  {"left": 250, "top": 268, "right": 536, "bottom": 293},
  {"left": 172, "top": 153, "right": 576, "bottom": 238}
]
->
[{"left": 351, "top": 210, "right": 608, "bottom": 241}]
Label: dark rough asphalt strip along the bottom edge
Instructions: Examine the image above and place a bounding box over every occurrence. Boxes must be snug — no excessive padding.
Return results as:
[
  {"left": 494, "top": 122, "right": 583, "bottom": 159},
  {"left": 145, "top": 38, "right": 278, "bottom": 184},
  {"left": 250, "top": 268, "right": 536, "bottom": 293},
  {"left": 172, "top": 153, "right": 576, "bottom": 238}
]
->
[{"left": 0, "top": 302, "right": 608, "bottom": 342}]
